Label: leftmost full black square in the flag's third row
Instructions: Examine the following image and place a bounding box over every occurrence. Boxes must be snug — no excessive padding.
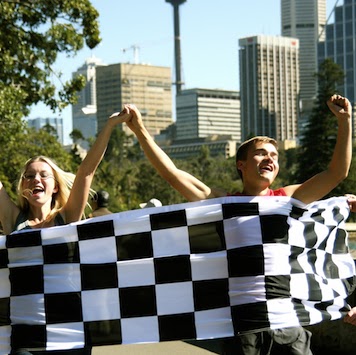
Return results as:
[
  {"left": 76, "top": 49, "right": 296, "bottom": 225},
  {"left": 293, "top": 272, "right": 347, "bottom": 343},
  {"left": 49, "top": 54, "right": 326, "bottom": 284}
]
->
[{"left": 9, "top": 265, "right": 44, "bottom": 296}]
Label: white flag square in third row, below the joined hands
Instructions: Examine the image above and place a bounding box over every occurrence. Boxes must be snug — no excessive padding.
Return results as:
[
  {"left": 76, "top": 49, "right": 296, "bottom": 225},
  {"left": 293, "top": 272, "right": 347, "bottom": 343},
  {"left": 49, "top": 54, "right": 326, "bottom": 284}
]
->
[{"left": 117, "top": 259, "right": 155, "bottom": 287}]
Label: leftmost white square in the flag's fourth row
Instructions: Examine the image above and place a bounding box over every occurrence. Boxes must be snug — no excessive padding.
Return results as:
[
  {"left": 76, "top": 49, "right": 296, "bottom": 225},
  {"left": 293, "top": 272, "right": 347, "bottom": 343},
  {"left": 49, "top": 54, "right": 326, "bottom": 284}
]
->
[{"left": 10, "top": 294, "right": 46, "bottom": 325}]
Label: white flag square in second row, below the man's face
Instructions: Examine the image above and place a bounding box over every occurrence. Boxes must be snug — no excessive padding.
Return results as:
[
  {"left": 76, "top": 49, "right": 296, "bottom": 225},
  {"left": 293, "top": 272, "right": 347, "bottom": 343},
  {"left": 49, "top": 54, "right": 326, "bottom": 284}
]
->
[{"left": 224, "top": 216, "right": 262, "bottom": 249}]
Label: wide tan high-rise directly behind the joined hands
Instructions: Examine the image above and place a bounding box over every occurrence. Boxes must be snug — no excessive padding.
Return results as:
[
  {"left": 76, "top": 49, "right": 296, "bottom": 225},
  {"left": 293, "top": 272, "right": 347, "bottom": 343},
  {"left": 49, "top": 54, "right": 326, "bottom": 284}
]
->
[{"left": 96, "top": 63, "right": 173, "bottom": 135}]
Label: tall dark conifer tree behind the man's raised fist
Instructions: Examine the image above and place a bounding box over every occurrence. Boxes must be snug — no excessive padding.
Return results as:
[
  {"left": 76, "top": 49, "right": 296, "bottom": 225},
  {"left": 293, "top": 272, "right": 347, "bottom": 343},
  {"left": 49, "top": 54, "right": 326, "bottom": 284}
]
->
[{"left": 295, "top": 58, "right": 344, "bottom": 196}]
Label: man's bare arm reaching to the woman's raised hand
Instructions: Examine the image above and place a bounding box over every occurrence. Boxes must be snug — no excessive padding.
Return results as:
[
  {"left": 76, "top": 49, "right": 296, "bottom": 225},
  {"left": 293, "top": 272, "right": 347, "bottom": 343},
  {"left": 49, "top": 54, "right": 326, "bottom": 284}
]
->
[{"left": 111, "top": 105, "right": 226, "bottom": 201}]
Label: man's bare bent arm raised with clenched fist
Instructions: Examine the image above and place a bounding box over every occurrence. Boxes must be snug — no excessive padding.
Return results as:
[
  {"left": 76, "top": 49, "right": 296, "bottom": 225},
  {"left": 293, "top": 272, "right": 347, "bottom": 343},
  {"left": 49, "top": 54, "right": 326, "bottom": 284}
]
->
[{"left": 286, "top": 95, "right": 352, "bottom": 203}]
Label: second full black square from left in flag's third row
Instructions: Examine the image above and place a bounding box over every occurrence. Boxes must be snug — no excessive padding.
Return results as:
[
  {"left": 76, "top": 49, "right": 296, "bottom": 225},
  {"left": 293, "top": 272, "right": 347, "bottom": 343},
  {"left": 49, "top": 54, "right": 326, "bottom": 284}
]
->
[{"left": 80, "top": 263, "right": 118, "bottom": 290}]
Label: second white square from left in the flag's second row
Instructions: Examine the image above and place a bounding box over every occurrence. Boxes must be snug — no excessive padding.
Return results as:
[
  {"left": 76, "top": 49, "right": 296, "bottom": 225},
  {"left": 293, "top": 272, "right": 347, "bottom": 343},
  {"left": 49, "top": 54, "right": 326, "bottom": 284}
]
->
[{"left": 79, "top": 237, "right": 117, "bottom": 264}]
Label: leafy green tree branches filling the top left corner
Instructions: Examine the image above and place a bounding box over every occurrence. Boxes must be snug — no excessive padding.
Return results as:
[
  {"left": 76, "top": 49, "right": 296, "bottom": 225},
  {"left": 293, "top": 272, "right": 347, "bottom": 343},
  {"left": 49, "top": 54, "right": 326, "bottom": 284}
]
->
[{"left": 0, "top": 0, "right": 100, "bottom": 119}]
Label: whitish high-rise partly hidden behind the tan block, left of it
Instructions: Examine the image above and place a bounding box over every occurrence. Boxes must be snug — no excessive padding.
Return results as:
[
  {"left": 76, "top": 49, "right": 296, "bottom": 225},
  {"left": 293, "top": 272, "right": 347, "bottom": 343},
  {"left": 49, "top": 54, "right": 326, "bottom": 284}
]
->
[{"left": 72, "top": 57, "right": 105, "bottom": 148}]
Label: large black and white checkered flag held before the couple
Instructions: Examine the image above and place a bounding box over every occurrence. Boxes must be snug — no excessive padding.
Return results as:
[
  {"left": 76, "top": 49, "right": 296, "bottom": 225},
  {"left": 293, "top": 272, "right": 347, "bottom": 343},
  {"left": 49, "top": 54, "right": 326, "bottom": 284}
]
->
[{"left": 0, "top": 197, "right": 355, "bottom": 354}]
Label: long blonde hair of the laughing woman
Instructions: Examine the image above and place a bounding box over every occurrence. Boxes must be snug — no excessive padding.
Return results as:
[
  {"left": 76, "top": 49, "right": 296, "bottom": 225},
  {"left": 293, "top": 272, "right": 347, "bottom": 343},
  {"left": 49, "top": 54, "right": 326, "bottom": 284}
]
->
[{"left": 17, "top": 155, "right": 75, "bottom": 220}]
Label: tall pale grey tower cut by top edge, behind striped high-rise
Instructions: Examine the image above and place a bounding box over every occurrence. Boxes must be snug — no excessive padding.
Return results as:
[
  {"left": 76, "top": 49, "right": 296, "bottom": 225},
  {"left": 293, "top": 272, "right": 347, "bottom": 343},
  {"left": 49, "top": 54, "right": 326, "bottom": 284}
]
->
[{"left": 281, "top": 0, "right": 326, "bottom": 114}]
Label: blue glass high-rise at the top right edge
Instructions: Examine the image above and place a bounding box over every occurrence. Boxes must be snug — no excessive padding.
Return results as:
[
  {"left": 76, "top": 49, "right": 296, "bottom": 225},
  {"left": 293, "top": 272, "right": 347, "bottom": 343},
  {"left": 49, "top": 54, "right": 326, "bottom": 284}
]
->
[{"left": 318, "top": 0, "right": 356, "bottom": 136}]
